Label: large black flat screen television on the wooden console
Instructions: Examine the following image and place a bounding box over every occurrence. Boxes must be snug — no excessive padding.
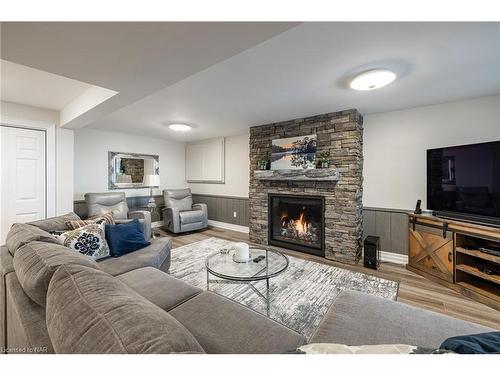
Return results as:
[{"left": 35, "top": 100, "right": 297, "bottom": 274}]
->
[{"left": 427, "top": 141, "right": 500, "bottom": 226}]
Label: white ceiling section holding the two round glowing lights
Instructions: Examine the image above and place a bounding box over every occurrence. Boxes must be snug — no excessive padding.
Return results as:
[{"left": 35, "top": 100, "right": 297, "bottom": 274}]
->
[{"left": 91, "top": 23, "right": 500, "bottom": 140}]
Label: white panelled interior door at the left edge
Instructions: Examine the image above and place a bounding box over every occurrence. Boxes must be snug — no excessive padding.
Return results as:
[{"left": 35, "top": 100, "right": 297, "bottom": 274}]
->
[{"left": 0, "top": 126, "right": 46, "bottom": 244}]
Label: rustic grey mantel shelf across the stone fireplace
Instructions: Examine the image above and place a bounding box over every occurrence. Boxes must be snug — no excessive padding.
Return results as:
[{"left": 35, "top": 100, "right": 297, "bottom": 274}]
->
[{"left": 253, "top": 168, "right": 340, "bottom": 181}]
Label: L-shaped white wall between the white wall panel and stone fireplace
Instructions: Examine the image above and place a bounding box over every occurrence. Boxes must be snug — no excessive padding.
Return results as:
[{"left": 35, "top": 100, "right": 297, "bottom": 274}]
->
[{"left": 189, "top": 133, "right": 250, "bottom": 198}]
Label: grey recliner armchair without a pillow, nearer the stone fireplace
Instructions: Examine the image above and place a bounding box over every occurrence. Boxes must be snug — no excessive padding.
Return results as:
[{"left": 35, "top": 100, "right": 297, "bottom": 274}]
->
[{"left": 163, "top": 189, "right": 208, "bottom": 233}]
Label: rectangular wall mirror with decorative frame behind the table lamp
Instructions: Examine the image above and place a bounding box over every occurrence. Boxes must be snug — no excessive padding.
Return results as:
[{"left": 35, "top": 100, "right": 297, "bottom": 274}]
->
[{"left": 108, "top": 151, "right": 160, "bottom": 190}]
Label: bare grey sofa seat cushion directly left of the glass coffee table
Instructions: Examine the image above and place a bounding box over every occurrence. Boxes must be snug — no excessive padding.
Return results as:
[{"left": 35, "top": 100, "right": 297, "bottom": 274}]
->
[{"left": 118, "top": 267, "right": 202, "bottom": 311}]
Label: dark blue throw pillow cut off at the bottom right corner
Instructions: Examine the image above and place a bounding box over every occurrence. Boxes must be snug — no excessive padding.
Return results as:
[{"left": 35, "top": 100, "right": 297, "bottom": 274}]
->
[{"left": 441, "top": 332, "right": 500, "bottom": 354}]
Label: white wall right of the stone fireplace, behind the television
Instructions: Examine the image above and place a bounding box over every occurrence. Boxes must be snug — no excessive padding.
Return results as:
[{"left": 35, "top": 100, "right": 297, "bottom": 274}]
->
[{"left": 363, "top": 95, "right": 500, "bottom": 209}]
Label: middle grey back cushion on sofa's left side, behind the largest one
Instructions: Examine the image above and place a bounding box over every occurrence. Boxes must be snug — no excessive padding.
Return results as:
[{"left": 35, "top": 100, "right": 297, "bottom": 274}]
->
[{"left": 14, "top": 241, "right": 99, "bottom": 306}]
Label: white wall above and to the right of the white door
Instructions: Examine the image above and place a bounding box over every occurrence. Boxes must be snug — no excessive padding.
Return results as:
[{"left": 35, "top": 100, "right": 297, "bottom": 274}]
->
[{"left": 0, "top": 102, "right": 73, "bottom": 215}]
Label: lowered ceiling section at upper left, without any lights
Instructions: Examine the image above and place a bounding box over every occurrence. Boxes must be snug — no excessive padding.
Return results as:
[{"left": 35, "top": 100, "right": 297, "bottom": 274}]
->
[{"left": 1, "top": 22, "right": 297, "bottom": 128}]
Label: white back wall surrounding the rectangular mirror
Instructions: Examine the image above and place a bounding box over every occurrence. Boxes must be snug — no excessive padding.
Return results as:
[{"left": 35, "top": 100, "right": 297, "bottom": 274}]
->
[{"left": 74, "top": 129, "right": 186, "bottom": 200}]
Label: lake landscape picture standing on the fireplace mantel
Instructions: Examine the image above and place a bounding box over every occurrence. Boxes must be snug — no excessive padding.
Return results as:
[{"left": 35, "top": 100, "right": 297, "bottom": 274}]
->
[{"left": 271, "top": 134, "right": 316, "bottom": 170}]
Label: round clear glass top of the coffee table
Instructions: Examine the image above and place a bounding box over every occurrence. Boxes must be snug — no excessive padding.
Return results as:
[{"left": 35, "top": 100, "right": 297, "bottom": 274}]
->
[{"left": 206, "top": 247, "right": 288, "bottom": 281}]
